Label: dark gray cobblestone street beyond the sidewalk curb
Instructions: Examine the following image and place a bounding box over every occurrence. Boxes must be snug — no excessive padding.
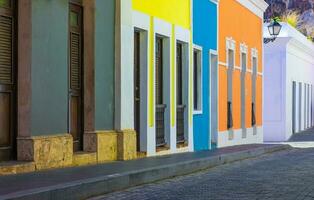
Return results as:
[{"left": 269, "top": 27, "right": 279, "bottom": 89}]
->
[{"left": 93, "top": 148, "right": 314, "bottom": 200}]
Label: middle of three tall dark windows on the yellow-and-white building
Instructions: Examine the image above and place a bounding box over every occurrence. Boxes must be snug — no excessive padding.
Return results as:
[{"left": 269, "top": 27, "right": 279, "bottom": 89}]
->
[{"left": 155, "top": 37, "right": 166, "bottom": 147}]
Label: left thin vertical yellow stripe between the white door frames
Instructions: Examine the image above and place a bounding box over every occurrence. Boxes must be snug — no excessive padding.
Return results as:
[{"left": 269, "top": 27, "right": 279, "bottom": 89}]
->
[{"left": 148, "top": 16, "right": 155, "bottom": 127}]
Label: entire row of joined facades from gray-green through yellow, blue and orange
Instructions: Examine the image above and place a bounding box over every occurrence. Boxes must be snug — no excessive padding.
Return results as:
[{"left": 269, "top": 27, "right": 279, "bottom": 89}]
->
[{"left": 0, "top": 0, "right": 274, "bottom": 174}]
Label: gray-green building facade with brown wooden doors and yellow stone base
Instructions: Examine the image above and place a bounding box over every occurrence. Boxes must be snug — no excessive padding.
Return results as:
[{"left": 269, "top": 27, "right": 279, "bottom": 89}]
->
[{"left": 0, "top": 0, "right": 136, "bottom": 173}]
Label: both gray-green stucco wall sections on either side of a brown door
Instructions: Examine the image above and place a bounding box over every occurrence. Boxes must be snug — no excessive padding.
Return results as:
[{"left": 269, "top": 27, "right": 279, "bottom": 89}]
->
[{"left": 31, "top": 0, "right": 115, "bottom": 136}]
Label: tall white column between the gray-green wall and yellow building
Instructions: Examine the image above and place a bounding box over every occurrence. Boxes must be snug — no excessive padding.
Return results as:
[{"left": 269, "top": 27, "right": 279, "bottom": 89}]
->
[{"left": 115, "top": 0, "right": 134, "bottom": 130}]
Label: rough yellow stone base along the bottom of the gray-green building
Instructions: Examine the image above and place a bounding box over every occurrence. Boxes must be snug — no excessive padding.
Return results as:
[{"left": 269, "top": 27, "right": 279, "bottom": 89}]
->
[{"left": 0, "top": 130, "right": 138, "bottom": 175}]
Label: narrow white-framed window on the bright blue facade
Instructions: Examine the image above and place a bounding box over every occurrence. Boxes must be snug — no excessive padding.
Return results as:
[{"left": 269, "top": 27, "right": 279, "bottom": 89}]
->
[{"left": 193, "top": 49, "right": 202, "bottom": 112}]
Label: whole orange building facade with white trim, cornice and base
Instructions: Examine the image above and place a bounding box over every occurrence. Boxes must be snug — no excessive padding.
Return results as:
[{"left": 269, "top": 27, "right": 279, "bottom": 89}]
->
[{"left": 218, "top": 0, "right": 267, "bottom": 147}]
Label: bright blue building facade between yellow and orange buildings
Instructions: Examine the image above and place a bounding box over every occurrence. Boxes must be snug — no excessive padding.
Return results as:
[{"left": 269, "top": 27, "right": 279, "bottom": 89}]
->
[{"left": 193, "top": 0, "right": 218, "bottom": 151}]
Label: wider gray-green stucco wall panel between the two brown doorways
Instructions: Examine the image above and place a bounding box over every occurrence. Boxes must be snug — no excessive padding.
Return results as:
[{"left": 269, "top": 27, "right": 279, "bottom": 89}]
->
[{"left": 31, "top": 0, "right": 68, "bottom": 135}]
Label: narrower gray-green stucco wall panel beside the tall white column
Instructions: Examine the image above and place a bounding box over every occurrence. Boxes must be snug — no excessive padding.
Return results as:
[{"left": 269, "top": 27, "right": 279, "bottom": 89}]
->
[{"left": 95, "top": 0, "right": 115, "bottom": 130}]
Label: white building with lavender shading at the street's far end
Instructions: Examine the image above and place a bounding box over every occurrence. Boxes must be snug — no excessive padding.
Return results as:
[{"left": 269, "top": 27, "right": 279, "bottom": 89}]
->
[{"left": 264, "top": 23, "right": 314, "bottom": 142}]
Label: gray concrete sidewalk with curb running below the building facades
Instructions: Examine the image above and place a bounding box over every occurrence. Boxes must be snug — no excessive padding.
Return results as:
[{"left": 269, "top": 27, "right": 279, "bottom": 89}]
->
[{"left": 0, "top": 144, "right": 291, "bottom": 200}]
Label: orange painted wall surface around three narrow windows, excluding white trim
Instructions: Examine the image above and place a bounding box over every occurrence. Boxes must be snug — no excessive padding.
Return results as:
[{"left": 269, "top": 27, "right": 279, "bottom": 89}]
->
[{"left": 219, "top": 0, "right": 263, "bottom": 131}]
